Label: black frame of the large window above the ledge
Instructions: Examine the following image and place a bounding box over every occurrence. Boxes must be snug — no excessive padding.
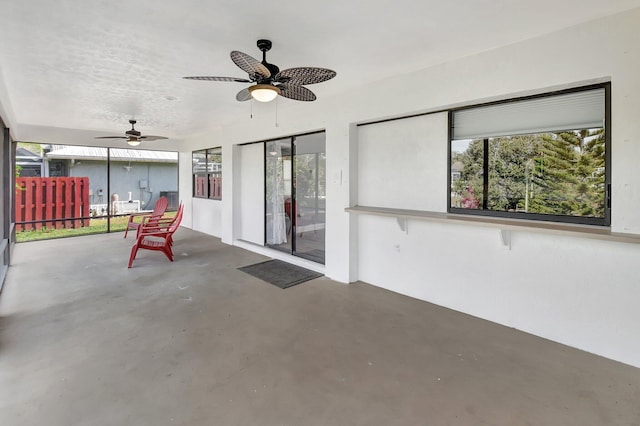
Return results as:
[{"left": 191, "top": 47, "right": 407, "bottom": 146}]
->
[{"left": 447, "top": 82, "right": 611, "bottom": 227}]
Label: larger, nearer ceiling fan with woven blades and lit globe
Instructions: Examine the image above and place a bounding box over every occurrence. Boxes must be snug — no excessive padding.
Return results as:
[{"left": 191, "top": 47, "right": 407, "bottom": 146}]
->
[{"left": 183, "top": 40, "right": 336, "bottom": 102}]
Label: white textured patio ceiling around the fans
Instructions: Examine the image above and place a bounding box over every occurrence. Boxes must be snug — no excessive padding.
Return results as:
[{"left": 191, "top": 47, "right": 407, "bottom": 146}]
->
[{"left": 0, "top": 0, "right": 640, "bottom": 143}]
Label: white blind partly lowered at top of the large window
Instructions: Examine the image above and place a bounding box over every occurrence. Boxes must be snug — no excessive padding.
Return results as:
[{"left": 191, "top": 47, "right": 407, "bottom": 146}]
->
[{"left": 453, "top": 88, "right": 605, "bottom": 140}]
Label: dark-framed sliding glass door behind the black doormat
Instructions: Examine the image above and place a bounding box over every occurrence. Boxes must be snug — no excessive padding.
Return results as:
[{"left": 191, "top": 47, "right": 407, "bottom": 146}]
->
[{"left": 265, "top": 132, "right": 326, "bottom": 263}]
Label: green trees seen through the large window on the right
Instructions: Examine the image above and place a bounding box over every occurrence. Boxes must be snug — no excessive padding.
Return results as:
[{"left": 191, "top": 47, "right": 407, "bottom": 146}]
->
[{"left": 452, "top": 130, "right": 605, "bottom": 217}]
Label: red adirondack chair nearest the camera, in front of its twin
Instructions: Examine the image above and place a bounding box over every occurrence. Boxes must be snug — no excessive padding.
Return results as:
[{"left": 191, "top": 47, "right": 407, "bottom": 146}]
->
[{"left": 129, "top": 203, "right": 184, "bottom": 268}]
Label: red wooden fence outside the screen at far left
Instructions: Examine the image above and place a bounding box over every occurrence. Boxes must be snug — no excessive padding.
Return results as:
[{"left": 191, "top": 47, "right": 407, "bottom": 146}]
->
[{"left": 16, "top": 177, "right": 90, "bottom": 231}]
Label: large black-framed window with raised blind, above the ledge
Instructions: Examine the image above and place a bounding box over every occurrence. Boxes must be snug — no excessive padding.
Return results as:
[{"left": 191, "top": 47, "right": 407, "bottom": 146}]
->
[{"left": 449, "top": 84, "right": 611, "bottom": 226}]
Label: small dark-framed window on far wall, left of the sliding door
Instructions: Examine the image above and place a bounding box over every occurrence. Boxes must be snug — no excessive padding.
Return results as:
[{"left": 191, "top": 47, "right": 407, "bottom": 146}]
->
[{"left": 193, "top": 147, "right": 222, "bottom": 200}]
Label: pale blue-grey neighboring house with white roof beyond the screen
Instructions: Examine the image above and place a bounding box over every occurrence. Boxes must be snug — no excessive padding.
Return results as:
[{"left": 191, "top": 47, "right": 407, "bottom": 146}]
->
[{"left": 45, "top": 145, "right": 178, "bottom": 213}]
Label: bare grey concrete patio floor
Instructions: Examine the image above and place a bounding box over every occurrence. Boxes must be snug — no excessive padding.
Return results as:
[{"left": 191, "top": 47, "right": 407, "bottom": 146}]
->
[{"left": 0, "top": 229, "right": 640, "bottom": 426}]
